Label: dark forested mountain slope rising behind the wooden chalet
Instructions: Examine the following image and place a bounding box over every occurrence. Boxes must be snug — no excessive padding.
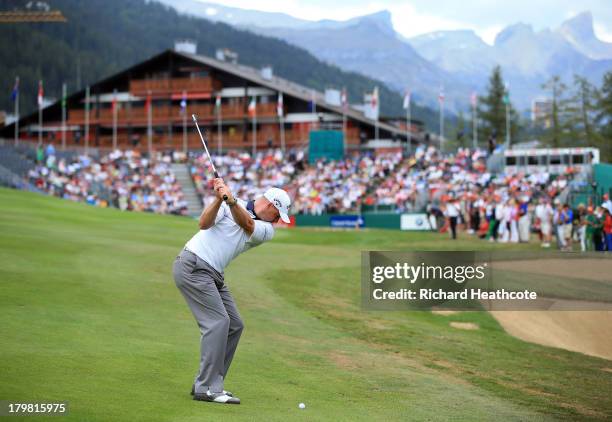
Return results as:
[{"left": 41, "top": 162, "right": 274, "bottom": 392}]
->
[{"left": 0, "top": 0, "right": 440, "bottom": 130}]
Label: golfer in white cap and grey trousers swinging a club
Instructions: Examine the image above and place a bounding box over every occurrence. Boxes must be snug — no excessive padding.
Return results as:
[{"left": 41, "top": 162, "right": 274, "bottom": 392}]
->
[{"left": 173, "top": 178, "right": 291, "bottom": 404}]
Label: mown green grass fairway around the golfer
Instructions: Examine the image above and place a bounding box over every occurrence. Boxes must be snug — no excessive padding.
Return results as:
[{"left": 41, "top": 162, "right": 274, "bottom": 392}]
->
[{"left": 0, "top": 189, "right": 612, "bottom": 421}]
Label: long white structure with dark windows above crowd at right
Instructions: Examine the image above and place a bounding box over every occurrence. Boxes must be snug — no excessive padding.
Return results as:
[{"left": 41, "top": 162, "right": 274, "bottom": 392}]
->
[{"left": 504, "top": 148, "right": 599, "bottom": 174}]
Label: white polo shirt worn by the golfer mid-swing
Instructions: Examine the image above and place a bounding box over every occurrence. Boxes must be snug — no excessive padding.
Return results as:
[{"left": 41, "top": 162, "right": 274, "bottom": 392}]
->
[{"left": 185, "top": 199, "right": 274, "bottom": 273}]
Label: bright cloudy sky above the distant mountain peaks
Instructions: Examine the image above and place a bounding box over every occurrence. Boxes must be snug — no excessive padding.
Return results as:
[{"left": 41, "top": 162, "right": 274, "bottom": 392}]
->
[{"left": 196, "top": 0, "right": 612, "bottom": 44}]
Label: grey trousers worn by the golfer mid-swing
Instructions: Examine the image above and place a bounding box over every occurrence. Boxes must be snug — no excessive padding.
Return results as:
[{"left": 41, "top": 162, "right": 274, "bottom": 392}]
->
[{"left": 172, "top": 249, "right": 244, "bottom": 393}]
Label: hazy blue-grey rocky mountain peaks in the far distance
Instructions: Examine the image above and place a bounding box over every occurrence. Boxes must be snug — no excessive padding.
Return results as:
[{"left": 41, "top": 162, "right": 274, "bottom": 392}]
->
[{"left": 158, "top": 0, "right": 612, "bottom": 111}]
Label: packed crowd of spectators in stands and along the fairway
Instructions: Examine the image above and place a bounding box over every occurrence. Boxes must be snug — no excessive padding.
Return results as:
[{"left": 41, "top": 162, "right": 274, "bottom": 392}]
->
[{"left": 14, "top": 144, "right": 612, "bottom": 251}]
